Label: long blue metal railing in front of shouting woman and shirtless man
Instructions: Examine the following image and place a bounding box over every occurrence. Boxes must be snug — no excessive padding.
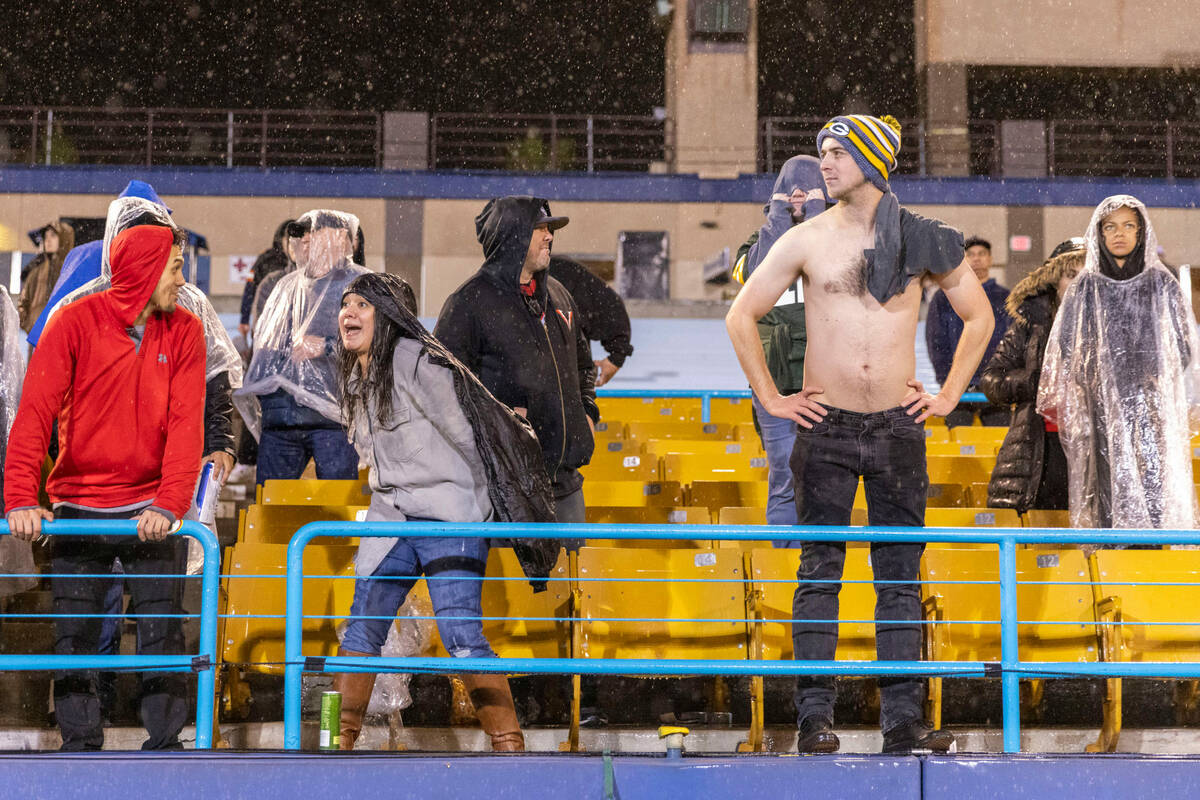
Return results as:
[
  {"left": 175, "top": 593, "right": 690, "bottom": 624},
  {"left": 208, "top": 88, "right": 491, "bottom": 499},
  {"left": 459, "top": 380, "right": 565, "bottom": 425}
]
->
[{"left": 276, "top": 522, "right": 1200, "bottom": 752}]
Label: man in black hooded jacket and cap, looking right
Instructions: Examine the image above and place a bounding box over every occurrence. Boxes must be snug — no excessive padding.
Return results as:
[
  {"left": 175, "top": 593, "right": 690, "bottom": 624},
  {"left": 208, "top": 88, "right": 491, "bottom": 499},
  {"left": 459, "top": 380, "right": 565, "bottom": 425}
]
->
[{"left": 433, "top": 196, "right": 600, "bottom": 523}]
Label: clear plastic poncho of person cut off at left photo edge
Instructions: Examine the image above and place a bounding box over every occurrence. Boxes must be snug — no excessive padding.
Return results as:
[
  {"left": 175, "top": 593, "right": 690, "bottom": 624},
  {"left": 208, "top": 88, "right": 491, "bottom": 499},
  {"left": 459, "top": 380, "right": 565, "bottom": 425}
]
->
[{"left": 0, "top": 289, "right": 37, "bottom": 597}]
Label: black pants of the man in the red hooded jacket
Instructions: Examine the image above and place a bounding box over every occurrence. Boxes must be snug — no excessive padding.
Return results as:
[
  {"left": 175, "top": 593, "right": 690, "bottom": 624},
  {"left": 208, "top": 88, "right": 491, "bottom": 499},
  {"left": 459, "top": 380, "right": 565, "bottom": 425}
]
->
[{"left": 50, "top": 506, "right": 188, "bottom": 750}]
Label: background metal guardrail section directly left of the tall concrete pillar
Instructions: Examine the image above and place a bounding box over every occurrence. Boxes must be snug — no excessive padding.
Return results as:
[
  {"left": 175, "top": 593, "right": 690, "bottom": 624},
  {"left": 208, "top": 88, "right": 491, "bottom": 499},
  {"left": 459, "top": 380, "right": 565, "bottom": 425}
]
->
[{"left": 430, "top": 114, "right": 671, "bottom": 173}]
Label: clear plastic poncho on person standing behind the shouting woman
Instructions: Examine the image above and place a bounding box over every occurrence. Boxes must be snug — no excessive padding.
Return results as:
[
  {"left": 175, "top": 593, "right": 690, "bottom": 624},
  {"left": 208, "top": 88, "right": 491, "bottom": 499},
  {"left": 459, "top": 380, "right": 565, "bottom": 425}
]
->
[{"left": 234, "top": 210, "right": 368, "bottom": 438}]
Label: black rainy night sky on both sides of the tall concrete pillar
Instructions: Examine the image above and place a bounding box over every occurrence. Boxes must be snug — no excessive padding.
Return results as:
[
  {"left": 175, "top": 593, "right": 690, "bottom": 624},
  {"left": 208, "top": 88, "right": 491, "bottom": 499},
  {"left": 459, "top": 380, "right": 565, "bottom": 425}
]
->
[{"left": 0, "top": 0, "right": 917, "bottom": 116}]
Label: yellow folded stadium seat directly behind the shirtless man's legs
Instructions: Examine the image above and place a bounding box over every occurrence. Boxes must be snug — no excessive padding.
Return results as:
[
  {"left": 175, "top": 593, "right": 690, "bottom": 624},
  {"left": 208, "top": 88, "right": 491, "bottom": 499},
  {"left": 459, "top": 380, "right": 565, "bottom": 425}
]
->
[{"left": 745, "top": 542, "right": 876, "bottom": 752}]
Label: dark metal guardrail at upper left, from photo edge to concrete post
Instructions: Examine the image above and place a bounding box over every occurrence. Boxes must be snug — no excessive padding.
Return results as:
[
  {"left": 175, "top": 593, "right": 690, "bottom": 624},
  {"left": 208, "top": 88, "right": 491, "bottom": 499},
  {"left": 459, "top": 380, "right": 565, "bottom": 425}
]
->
[{"left": 0, "top": 107, "right": 383, "bottom": 169}]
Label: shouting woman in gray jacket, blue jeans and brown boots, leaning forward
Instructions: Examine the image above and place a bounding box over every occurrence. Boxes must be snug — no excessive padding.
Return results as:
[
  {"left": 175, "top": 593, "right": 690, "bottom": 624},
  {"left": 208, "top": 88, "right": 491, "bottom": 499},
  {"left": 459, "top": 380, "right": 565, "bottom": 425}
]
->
[{"left": 334, "top": 273, "right": 557, "bottom": 751}]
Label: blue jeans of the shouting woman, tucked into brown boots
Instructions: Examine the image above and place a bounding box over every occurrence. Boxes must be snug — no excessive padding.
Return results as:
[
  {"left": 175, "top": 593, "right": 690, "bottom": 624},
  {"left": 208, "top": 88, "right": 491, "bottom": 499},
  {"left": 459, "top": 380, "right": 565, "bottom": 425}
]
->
[{"left": 342, "top": 536, "right": 496, "bottom": 658}]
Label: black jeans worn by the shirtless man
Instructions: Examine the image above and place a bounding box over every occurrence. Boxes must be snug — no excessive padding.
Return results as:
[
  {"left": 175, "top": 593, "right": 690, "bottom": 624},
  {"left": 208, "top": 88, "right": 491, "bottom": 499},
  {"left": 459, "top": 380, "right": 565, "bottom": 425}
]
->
[{"left": 791, "top": 408, "right": 929, "bottom": 733}]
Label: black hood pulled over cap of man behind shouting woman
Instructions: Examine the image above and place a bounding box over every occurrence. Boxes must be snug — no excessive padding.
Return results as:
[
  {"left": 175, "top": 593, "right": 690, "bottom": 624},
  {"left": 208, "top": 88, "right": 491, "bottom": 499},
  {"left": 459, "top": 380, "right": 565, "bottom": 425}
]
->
[{"left": 475, "top": 194, "right": 566, "bottom": 293}]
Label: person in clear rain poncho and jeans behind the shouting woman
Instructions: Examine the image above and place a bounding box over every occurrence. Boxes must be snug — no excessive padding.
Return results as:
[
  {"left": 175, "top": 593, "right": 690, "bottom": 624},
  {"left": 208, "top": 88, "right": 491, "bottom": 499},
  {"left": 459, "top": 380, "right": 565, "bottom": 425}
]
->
[{"left": 235, "top": 210, "right": 367, "bottom": 483}]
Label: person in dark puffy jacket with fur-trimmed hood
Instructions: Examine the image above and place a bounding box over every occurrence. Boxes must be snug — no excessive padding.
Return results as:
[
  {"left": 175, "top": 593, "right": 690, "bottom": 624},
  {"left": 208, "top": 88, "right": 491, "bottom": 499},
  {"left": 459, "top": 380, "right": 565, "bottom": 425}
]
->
[{"left": 980, "top": 239, "right": 1085, "bottom": 513}]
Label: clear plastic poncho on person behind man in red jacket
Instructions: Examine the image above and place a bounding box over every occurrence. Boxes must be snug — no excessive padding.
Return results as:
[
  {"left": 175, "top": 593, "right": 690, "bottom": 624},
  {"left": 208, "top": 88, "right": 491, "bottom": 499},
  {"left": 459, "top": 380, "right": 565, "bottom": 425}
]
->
[{"left": 50, "top": 197, "right": 242, "bottom": 389}]
